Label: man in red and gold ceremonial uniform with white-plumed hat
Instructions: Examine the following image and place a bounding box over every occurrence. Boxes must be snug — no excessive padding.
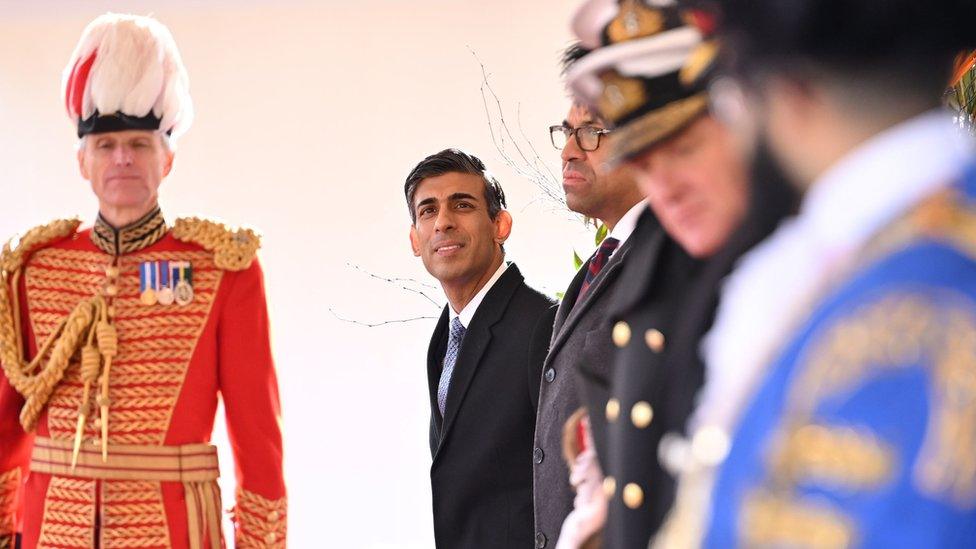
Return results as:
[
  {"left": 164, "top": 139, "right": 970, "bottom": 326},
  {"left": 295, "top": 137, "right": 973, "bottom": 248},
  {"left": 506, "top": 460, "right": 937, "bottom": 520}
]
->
[{"left": 0, "top": 14, "right": 286, "bottom": 549}]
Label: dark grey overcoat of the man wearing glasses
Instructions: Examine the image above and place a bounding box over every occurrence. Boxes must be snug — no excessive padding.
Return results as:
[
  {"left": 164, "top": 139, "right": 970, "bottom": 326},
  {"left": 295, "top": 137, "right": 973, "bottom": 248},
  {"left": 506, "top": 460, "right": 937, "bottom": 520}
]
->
[{"left": 532, "top": 231, "right": 633, "bottom": 549}]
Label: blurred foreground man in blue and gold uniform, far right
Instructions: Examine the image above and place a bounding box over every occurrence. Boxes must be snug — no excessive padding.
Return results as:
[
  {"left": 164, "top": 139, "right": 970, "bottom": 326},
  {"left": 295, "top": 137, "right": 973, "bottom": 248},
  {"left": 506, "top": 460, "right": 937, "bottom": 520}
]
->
[{"left": 665, "top": 0, "right": 976, "bottom": 547}]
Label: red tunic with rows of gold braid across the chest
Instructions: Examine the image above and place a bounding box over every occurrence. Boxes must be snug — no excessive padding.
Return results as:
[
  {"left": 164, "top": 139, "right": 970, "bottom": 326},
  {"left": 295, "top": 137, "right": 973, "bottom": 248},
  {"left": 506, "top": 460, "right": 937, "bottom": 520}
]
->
[{"left": 0, "top": 210, "right": 286, "bottom": 549}]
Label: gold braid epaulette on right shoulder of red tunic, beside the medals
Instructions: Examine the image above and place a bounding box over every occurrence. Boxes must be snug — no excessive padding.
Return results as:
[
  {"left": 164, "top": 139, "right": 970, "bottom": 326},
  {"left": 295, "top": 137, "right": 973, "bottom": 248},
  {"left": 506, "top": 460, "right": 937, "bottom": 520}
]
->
[{"left": 173, "top": 217, "right": 261, "bottom": 271}]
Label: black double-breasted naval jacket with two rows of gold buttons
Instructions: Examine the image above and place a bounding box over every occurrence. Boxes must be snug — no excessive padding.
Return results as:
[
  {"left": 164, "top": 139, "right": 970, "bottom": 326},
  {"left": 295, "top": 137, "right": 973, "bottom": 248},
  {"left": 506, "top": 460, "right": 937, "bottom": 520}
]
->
[{"left": 587, "top": 208, "right": 700, "bottom": 549}]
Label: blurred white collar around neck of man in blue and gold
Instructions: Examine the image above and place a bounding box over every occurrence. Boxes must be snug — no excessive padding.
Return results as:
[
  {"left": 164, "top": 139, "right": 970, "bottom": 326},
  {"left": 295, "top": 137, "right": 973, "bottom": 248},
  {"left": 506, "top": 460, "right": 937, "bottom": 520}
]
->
[{"left": 799, "top": 109, "right": 973, "bottom": 254}]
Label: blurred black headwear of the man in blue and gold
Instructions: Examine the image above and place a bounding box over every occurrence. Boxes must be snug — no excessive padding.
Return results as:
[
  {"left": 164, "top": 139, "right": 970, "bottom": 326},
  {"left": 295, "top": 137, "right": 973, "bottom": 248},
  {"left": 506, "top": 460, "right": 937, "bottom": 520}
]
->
[{"left": 715, "top": 0, "right": 976, "bottom": 95}]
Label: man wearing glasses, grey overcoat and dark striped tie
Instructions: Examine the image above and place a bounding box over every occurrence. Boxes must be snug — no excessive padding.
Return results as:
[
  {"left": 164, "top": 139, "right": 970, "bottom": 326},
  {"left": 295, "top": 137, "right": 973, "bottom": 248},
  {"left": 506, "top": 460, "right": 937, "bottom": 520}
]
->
[{"left": 533, "top": 46, "right": 646, "bottom": 549}]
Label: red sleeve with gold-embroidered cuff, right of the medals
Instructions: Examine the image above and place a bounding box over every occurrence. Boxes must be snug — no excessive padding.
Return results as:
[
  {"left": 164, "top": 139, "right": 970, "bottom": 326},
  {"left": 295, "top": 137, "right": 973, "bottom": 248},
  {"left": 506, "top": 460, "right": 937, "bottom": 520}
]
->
[{"left": 217, "top": 259, "right": 287, "bottom": 547}]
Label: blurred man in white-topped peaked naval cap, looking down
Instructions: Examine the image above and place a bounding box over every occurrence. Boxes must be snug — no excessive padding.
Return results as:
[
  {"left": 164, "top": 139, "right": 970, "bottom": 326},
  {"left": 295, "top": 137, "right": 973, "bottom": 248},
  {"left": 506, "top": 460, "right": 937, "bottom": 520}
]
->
[{"left": 568, "top": 1, "right": 792, "bottom": 547}]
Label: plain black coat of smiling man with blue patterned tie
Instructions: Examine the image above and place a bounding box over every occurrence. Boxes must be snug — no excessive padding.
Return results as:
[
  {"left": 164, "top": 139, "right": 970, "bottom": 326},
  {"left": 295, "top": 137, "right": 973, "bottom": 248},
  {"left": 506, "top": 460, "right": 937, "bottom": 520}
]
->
[{"left": 427, "top": 264, "right": 555, "bottom": 549}]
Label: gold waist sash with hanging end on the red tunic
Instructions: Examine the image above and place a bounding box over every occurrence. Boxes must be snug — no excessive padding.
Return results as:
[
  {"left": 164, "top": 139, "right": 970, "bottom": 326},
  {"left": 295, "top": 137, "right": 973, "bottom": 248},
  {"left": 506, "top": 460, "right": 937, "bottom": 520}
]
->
[{"left": 30, "top": 437, "right": 222, "bottom": 549}]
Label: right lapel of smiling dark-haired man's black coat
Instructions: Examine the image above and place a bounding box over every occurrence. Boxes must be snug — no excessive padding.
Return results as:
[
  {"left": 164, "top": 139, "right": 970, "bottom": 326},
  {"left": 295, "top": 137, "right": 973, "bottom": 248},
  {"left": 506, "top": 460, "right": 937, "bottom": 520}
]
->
[{"left": 434, "top": 263, "right": 523, "bottom": 462}]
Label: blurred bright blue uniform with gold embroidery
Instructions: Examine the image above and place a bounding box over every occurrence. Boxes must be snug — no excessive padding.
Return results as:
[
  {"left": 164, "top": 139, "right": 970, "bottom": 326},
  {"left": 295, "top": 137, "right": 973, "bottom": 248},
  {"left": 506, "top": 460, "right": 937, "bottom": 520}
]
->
[{"left": 705, "top": 167, "right": 976, "bottom": 548}]
